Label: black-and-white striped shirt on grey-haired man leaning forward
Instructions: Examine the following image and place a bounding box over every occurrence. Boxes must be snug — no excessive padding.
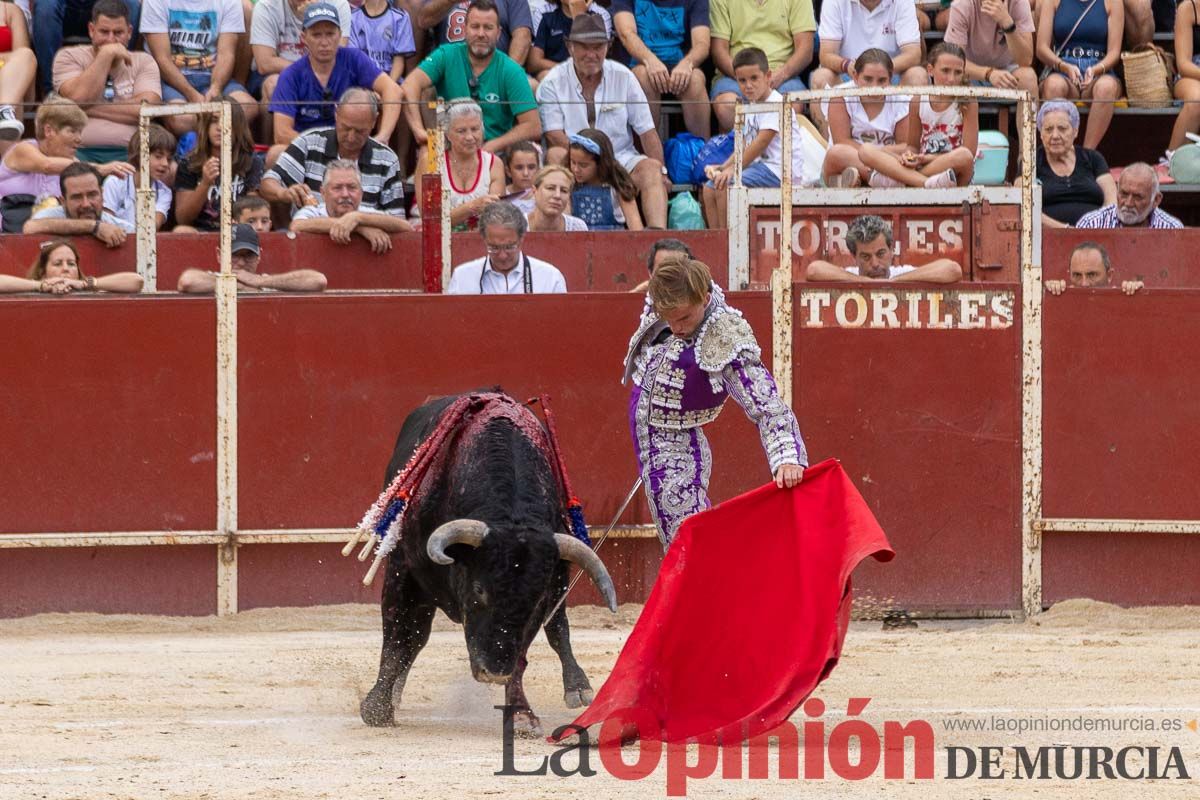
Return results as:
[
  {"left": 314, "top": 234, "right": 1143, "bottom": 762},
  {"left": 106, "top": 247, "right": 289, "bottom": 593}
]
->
[{"left": 264, "top": 128, "right": 404, "bottom": 219}]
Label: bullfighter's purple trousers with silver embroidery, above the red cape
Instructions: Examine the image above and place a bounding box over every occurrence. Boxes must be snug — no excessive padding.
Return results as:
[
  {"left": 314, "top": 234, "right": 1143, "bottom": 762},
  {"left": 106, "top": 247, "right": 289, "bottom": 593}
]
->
[{"left": 637, "top": 426, "right": 713, "bottom": 547}]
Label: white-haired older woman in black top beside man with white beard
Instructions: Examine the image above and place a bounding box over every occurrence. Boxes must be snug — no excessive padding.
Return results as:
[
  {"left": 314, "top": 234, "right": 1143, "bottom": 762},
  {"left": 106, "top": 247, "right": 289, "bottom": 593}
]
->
[{"left": 1037, "top": 101, "right": 1117, "bottom": 228}]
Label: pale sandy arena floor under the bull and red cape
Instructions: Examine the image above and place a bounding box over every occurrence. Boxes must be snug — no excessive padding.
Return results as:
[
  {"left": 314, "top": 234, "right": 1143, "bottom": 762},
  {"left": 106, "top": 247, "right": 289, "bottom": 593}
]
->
[{"left": 0, "top": 601, "right": 1200, "bottom": 800}]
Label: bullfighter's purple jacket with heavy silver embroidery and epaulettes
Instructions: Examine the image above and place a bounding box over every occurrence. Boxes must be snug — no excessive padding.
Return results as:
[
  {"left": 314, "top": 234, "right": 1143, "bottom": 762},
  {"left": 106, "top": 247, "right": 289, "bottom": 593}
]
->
[{"left": 622, "top": 284, "right": 808, "bottom": 474}]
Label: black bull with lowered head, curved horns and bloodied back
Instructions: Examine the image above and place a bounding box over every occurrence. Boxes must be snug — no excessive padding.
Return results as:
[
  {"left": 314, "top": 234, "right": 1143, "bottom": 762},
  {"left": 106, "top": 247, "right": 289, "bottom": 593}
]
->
[{"left": 360, "top": 397, "right": 617, "bottom": 733}]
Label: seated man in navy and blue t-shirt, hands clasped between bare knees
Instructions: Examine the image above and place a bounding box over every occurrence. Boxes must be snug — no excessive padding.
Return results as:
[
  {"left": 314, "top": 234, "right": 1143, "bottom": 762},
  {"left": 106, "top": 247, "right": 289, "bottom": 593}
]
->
[{"left": 614, "top": 0, "right": 713, "bottom": 139}]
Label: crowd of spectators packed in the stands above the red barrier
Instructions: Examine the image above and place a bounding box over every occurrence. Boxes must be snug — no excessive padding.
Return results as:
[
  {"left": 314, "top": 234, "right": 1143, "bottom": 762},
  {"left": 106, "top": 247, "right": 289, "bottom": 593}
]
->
[{"left": 0, "top": 0, "right": 1200, "bottom": 283}]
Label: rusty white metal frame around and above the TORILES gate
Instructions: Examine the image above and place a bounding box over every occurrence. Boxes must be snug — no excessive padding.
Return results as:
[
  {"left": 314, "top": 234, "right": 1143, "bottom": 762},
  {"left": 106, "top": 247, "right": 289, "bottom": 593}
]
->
[{"left": 730, "top": 86, "right": 1065, "bottom": 614}]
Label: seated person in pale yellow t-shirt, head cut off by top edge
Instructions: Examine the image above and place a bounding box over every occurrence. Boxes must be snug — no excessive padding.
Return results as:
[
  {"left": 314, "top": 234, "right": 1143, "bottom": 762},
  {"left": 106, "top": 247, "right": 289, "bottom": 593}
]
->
[{"left": 708, "top": 0, "right": 820, "bottom": 131}]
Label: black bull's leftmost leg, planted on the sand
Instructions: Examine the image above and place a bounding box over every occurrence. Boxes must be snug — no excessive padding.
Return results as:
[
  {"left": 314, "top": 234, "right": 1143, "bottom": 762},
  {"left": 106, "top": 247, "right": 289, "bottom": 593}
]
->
[{"left": 359, "top": 559, "right": 434, "bottom": 727}]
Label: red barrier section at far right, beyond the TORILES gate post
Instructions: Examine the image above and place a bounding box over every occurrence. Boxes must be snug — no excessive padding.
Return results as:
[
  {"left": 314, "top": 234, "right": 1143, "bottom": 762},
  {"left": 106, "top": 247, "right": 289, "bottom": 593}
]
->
[{"left": 1043, "top": 289, "right": 1200, "bottom": 604}]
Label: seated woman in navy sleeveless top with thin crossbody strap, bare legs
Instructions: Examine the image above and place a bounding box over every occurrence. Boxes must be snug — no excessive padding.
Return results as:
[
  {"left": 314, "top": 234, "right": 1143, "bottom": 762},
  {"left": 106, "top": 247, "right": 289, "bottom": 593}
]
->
[{"left": 1037, "top": 0, "right": 1124, "bottom": 150}]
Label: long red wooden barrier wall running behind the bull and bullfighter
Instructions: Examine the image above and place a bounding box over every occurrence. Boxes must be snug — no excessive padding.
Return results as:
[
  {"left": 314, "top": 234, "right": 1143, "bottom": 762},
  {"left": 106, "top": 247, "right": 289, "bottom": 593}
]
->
[{"left": 0, "top": 287, "right": 1200, "bottom": 615}]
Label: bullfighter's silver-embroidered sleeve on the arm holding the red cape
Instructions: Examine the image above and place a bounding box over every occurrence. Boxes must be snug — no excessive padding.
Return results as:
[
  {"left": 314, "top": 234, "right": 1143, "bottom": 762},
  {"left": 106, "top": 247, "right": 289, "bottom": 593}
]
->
[{"left": 721, "top": 350, "right": 809, "bottom": 475}]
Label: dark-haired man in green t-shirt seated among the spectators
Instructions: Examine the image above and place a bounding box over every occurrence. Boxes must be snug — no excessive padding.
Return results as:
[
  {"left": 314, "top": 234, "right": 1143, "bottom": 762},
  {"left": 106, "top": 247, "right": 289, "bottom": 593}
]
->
[{"left": 403, "top": 0, "right": 541, "bottom": 152}]
